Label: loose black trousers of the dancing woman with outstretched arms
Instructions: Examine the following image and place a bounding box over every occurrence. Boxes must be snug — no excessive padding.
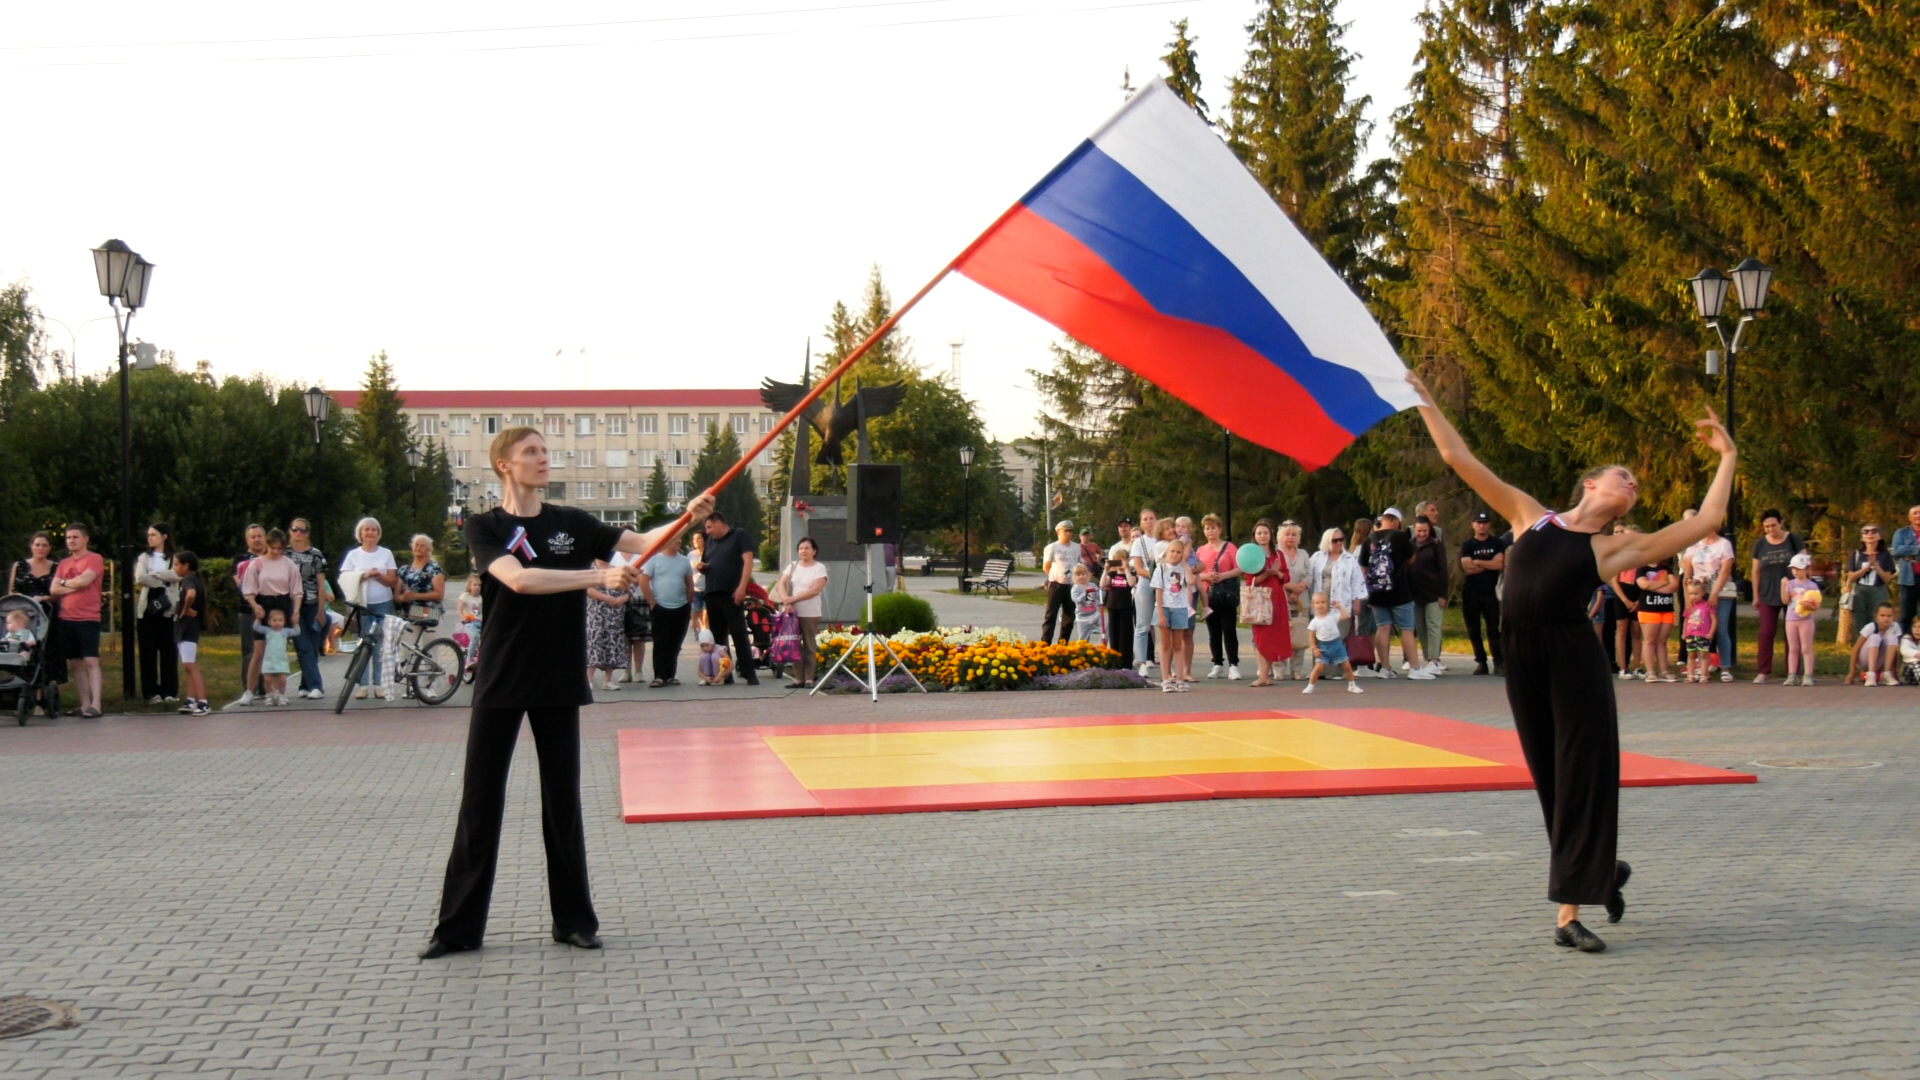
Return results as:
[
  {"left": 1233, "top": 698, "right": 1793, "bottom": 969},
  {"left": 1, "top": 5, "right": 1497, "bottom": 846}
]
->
[{"left": 1505, "top": 623, "right": 1620, "bottom": 903}]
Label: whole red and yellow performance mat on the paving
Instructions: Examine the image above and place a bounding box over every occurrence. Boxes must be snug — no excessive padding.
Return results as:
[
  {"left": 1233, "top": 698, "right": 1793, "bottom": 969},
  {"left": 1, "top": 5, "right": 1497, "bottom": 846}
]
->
[{"left": 620, "top": 709, "right": 1757, "bottom": 822}]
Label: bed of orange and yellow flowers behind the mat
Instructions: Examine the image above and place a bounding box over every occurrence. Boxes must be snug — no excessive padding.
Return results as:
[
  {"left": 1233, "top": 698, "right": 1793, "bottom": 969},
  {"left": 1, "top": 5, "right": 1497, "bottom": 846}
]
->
[{"left": 814, "top": 626, "right": 1119, "bottom": 690}]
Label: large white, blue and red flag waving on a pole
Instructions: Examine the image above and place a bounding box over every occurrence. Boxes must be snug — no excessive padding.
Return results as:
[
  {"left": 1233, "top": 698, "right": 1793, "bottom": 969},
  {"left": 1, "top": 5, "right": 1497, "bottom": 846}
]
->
[{"left": 954, "top": 79, "right": 1417, "bottom": 469}]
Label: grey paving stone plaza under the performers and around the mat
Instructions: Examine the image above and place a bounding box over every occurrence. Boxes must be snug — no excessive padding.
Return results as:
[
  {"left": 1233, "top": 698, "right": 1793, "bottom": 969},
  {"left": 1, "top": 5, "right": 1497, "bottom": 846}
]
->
[{"left": 0, "top": 580, "right": 1920, "bottom": 1080}]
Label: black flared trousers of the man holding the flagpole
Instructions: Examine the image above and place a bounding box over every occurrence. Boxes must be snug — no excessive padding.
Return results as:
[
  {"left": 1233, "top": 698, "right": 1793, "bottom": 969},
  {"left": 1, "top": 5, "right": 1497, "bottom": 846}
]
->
[{"left": 434, "top": 705, "right": 599, "bottom": 945}]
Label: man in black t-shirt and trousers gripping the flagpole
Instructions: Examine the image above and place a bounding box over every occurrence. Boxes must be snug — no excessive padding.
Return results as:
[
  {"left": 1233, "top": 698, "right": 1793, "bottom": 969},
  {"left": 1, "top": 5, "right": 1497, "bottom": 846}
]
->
[{"left": 420, "top": 427, "right": 712, "bottom": 961}]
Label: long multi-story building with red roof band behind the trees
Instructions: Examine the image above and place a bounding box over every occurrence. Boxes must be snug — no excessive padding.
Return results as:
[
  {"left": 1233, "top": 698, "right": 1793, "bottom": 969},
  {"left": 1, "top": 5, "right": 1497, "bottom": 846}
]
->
[{"left": 334, "top": 390, "right": 780, "bottom": 525}]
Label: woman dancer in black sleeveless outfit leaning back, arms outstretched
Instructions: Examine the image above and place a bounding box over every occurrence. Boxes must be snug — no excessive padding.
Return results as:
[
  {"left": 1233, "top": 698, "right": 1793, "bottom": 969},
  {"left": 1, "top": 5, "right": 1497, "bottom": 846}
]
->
[{"left": 1407, "top": 373, "right": 1734, "bottom": 953}]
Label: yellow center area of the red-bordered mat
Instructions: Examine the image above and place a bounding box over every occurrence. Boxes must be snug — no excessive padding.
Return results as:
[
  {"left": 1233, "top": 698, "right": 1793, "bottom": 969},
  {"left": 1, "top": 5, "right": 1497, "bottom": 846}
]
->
[{"left": 766, "top": 719, "right": 1498, "bottom": 790}]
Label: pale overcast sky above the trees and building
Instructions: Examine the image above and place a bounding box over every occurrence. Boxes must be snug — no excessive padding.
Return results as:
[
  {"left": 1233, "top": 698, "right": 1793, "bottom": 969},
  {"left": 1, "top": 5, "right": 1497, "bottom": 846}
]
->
[{"left": 0, "top": 0, "right": 1421, "bottom": 438}]
